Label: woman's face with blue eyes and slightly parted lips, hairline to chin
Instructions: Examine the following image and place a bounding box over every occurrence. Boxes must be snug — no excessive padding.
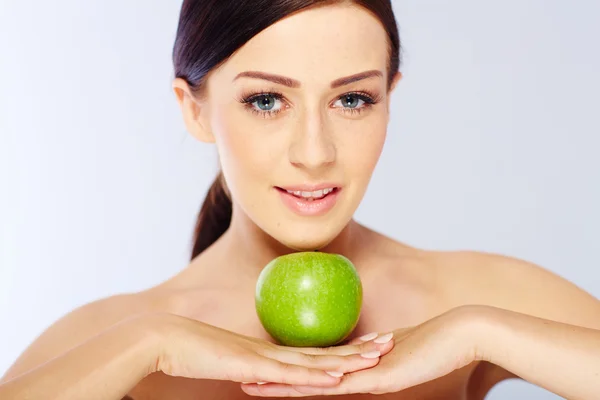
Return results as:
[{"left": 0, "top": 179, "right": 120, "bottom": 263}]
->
[{"left": 179, "top": 5, "right": 404, "bottom": 250}]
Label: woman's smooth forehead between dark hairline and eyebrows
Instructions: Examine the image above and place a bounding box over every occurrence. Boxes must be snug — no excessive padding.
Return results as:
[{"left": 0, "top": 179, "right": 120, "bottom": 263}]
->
[{"left": 216, "top": 4, "right": 389, "bottom": 85}]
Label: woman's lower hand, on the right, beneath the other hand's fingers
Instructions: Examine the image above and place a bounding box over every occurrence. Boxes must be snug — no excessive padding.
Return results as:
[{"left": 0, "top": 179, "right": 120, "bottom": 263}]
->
[{"left": 242, "top": 307, "right": 483, "bottom": 397}]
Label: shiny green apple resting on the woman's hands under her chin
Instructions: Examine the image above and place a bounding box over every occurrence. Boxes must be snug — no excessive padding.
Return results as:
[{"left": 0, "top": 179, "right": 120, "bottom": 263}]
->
[{"left": 255, "top": 252, "right": 363, "bottom": 347}]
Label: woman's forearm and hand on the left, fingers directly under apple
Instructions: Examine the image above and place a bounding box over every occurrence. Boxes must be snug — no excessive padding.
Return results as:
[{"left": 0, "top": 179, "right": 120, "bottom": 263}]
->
[{"left": 0, "top": 314, "right": 393, "bottom": 400}]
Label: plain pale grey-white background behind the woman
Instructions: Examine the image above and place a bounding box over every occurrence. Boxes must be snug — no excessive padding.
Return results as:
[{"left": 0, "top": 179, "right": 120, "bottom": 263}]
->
[{"left": 0, "top": 0, "right": 600, "bottom": 399}]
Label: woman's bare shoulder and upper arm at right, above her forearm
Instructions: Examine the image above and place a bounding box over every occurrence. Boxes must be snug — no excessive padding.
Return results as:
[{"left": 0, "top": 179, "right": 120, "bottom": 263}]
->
[{"left": 428, "top": 251, "right": 600, "bottom": 328}]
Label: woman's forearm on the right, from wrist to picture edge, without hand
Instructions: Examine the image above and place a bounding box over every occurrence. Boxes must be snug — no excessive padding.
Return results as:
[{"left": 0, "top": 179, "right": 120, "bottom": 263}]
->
[{"left": 474, "top": 307, "right": 600, "bottom": 399}]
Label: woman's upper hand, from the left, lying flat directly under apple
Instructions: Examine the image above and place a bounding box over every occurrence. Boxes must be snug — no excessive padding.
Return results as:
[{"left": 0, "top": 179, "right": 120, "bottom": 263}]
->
[{"left": 151, "top": 315, "right": 393, "bottom": 388}]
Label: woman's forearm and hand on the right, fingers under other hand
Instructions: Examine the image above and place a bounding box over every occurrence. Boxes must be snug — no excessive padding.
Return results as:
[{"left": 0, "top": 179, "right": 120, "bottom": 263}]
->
[{"left": 242, "top": 306, "right": 600, "bottom": 400}]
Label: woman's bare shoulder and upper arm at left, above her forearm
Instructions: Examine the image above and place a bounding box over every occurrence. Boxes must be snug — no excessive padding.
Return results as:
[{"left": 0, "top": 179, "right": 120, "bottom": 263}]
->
[{"left": 1, "top": 291, "right": 162, "bottom": 380}]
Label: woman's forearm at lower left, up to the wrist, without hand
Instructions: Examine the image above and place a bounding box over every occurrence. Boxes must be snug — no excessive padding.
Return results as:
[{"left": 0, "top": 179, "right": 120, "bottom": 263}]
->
[{"left": 0, "top": 318, "right": 159, "bottom": 400}]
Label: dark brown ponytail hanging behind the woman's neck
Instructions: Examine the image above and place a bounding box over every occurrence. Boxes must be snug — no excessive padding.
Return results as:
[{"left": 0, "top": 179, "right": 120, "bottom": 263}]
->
[{"left": 192, "top": 172, "right": 231, "bottom": 259}]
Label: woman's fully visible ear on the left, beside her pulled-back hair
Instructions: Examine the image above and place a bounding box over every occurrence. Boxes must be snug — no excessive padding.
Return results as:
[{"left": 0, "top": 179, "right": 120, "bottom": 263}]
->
[{"left": 173, "top": 78, "right": 215, "bottom": 143}]
